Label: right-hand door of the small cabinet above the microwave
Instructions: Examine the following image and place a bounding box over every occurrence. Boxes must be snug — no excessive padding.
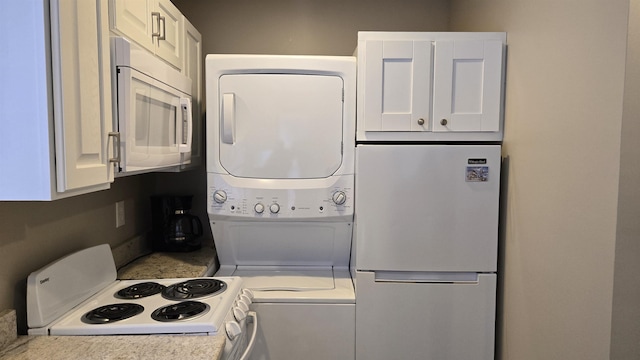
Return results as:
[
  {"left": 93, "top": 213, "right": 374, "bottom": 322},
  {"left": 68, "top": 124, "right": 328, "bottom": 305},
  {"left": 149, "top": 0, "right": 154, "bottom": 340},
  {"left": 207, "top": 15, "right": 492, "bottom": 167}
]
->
[{"left": 155, "top": 0, "right": 183, "bottom": 70}]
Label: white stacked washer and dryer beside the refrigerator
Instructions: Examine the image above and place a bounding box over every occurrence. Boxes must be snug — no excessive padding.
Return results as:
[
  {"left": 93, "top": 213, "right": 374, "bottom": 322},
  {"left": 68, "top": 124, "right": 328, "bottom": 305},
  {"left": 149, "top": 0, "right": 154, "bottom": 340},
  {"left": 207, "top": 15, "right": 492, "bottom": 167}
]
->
[{"left": 206, "top": 55, "right": 356, "bottom": 360}]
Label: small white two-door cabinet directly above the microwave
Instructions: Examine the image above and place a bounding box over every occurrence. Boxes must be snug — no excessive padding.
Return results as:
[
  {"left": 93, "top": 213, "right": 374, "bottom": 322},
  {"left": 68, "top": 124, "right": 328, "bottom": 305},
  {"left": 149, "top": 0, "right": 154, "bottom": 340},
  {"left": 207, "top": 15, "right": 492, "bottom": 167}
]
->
[{"left": 110, "top": 0, "right": 184, "bottom": 70}]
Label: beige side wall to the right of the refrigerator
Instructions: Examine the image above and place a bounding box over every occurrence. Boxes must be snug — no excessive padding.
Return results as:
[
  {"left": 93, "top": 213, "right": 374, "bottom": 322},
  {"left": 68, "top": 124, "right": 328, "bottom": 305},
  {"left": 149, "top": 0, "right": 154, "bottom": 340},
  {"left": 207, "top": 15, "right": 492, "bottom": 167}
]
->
[{"left": 451, "top": 0, "right": 628, "bottom": 360}]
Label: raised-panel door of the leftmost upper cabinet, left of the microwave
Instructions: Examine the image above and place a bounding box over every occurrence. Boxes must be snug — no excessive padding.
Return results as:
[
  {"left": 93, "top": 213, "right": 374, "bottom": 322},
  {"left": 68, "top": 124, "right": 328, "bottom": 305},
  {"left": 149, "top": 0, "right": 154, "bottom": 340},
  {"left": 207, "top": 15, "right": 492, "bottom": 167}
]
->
[{"left": 51, "top": 0, "right": 113, "bottom": 192}]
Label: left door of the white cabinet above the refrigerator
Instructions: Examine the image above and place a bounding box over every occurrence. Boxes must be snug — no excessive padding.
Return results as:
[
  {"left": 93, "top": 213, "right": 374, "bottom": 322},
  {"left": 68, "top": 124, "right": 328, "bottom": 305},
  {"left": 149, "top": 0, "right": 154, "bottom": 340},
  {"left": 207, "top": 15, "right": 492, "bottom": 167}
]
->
[{"left": 364, "top": 40, "right": 432, "bottom": 131}]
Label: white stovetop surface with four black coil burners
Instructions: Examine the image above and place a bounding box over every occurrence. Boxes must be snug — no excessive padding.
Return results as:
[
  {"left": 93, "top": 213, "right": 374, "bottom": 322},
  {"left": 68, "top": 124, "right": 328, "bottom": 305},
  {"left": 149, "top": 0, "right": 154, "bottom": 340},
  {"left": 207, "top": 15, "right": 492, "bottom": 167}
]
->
[{"left": 49, "top": 277, "right": 246, "bottom": 335}]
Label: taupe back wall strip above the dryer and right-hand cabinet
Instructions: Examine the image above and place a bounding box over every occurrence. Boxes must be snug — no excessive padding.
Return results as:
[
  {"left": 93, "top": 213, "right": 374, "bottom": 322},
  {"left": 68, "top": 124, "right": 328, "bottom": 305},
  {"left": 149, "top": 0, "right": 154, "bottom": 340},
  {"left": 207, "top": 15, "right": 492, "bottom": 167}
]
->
[{"left": 173, "top": 0, "right": 450, "bottom": 55}]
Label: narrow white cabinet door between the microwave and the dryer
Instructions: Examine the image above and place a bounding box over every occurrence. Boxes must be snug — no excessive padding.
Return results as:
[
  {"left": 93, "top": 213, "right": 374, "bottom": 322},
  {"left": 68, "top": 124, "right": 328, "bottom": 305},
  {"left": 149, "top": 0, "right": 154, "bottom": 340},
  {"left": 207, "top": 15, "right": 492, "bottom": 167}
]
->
[{"left": 182, "top": 19, "right": 203, "bottom": 165}]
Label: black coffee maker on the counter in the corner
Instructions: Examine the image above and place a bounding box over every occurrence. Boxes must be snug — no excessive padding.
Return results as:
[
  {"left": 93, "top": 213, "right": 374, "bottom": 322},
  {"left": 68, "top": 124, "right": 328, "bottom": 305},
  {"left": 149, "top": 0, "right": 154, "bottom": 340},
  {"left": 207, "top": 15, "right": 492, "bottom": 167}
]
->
[{"left": 150, "top": 195, "right": 202, "bottom": 252}]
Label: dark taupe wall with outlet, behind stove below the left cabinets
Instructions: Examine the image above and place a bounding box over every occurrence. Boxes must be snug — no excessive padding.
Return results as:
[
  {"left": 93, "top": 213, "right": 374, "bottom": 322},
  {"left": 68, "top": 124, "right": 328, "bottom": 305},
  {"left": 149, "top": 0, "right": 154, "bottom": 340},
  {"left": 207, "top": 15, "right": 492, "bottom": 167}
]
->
[{"left": 0, "top": 174, "right": 155, "bottom": 333}]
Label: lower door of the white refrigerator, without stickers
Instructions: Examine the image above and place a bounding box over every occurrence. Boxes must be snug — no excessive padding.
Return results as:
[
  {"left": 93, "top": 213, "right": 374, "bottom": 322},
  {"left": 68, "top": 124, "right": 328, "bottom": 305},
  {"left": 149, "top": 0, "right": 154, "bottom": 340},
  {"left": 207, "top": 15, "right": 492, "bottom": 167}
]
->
[{"left": 356, "top": 271, "right": 496, "bottom": 360}]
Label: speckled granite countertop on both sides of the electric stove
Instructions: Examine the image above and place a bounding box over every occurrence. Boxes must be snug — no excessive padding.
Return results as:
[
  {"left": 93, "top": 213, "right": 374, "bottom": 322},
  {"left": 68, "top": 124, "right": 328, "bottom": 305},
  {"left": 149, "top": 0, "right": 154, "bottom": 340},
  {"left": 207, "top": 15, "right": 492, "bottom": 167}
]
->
[{"left": 0, "top": 247, "right": 226, "bottom": 360}]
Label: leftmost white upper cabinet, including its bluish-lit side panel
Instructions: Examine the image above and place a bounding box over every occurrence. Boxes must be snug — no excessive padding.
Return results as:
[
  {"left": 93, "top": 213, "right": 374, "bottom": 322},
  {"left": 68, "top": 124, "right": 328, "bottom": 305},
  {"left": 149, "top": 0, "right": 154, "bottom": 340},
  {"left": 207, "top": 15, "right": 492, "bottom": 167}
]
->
[{"left": 0, "top": 0, "right": 113, "bottom": 200}]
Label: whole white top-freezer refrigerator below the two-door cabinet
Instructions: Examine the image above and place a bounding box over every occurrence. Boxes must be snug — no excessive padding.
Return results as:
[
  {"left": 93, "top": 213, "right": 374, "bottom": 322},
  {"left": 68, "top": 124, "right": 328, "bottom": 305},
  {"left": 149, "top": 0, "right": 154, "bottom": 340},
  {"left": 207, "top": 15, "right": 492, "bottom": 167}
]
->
[{"left": 355, "top": 142, "right": 501, "bottom": 360}]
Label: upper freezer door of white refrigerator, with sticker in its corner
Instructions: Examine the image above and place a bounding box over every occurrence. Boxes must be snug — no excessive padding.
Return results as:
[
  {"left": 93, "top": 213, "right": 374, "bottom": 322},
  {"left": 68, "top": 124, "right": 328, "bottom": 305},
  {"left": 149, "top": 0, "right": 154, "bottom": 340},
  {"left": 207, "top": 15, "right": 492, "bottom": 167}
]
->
[{"left": 355, "top": 145, "right": 500, "bottom": 272}]
